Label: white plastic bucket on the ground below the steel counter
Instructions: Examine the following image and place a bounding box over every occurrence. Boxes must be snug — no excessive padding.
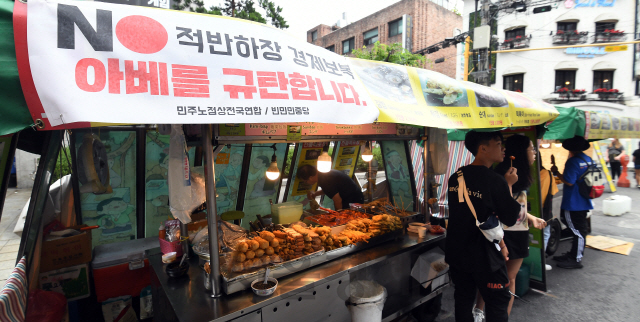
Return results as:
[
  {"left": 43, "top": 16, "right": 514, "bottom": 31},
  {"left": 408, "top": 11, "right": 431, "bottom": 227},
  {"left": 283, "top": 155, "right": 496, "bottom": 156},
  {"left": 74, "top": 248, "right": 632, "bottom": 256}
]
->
[{"left": 349, "top": 281, "right": 387, "bottom": 322}]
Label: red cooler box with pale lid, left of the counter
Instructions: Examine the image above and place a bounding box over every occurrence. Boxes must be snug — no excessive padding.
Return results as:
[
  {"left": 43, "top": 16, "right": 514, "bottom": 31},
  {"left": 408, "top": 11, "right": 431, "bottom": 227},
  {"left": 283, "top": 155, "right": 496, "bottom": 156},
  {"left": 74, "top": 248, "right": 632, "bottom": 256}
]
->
[{"left": 91, "top": 237, "right": 158, "bottom": 302}]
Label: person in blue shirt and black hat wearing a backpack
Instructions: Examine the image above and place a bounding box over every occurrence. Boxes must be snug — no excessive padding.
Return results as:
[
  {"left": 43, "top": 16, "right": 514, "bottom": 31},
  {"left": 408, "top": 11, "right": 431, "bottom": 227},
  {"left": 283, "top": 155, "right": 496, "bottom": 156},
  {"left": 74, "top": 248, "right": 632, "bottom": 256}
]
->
[{"left": 551, "top": 135, "right": 604, "bottom": 269}]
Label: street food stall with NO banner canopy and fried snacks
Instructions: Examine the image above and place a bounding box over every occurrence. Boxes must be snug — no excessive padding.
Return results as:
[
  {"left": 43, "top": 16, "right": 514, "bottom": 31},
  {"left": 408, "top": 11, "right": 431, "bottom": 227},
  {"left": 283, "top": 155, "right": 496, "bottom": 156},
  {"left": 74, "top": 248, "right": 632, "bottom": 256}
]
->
[{"left": 0, "top": 0, "right": 557, "bottom": 321}]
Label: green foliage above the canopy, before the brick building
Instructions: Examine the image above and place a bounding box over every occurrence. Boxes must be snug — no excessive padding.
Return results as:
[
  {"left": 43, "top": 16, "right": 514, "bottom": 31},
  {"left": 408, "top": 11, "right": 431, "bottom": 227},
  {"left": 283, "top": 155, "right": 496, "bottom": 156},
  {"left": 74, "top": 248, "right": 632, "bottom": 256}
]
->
[{"left": 352, "top": 41, "right": 427, "bottom": 67}]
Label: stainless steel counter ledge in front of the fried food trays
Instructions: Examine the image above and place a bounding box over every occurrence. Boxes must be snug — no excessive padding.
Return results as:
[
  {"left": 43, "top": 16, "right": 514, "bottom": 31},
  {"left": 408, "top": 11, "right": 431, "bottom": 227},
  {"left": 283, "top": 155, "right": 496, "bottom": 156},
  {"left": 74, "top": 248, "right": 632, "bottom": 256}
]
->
[{"left": 149, "top": 234, "right": 445, "bottom": 322}]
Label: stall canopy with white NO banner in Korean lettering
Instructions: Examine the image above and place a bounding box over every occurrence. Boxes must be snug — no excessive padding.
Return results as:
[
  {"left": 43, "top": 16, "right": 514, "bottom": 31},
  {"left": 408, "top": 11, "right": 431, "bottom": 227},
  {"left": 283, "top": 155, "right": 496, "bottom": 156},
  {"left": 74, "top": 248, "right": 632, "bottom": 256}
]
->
[{"left": 1, "top": 0, "right": 558, "bottom": 132}]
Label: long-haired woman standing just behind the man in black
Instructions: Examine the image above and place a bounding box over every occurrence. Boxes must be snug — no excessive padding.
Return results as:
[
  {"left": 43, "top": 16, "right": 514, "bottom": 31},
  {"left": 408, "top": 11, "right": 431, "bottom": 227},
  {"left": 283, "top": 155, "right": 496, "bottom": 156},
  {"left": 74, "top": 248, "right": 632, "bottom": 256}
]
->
[{"left": 474, "top": 135, "right": 547, "bottom": 321}]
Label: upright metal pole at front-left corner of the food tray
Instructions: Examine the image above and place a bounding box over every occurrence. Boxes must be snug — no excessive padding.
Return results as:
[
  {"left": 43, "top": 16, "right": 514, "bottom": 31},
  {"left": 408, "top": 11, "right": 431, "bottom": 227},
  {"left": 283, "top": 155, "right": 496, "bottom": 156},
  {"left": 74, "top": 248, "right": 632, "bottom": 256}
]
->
[{"left": 208, "top": 124, "right": 222, "bottom": 297}]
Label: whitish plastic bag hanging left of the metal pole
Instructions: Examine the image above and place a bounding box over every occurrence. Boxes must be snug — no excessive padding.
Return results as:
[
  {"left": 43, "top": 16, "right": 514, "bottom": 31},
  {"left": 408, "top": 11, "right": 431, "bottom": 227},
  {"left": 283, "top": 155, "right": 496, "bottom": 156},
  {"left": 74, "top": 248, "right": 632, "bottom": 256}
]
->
[{"left": 168, "top": 124, "right": 192, "bottom": 224}]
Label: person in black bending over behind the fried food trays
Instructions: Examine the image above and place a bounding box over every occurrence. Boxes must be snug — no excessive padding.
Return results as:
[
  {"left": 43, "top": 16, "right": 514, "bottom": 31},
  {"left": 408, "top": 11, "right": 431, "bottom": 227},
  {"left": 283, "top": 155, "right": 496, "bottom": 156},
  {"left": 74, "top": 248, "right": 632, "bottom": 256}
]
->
[{"left": 297, "top": 165, "right": 364, "bottom": 210}]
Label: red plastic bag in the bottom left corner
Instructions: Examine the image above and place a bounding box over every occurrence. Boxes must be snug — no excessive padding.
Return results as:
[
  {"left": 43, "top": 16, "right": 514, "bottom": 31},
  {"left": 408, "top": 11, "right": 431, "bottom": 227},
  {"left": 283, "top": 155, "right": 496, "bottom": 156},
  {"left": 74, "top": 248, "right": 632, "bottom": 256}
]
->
[{"left": 25, "top": 289, "right": 67, "bottom": 322}]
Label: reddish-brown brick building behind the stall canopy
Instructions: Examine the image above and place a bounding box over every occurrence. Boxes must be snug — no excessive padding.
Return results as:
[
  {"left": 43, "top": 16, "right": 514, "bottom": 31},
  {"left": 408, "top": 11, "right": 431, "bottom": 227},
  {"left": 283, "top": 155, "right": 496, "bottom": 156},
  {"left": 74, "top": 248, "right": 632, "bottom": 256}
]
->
[{"left": 307, "top": 0, "right": 462, "bottom": 77}]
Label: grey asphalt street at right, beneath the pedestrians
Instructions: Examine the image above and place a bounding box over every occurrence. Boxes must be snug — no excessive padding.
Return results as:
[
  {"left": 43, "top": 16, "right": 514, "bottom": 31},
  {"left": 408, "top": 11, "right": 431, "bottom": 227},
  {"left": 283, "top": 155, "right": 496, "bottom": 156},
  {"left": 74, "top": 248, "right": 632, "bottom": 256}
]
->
[{"left": 438, "top": 180, "right": 640, "bottom": 322}]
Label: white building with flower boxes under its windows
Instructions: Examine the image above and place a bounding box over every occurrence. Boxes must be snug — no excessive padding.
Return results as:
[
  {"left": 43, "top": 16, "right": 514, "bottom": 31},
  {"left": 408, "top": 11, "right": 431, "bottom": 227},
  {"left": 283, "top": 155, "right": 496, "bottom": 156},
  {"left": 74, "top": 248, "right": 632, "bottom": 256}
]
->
[{"left": 464, "top": 0, "right": 640, "bottom": 117}]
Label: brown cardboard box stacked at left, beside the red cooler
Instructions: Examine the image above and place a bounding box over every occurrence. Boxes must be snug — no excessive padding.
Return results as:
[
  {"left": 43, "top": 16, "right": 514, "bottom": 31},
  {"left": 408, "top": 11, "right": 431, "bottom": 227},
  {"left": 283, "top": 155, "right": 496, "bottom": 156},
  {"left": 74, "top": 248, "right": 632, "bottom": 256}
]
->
[{"left": 40, "top": 225, "right": 91, "bottom": 272}]
